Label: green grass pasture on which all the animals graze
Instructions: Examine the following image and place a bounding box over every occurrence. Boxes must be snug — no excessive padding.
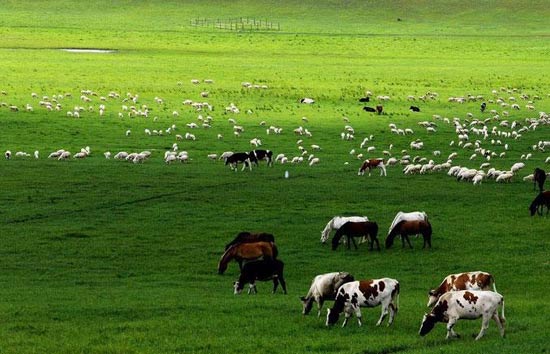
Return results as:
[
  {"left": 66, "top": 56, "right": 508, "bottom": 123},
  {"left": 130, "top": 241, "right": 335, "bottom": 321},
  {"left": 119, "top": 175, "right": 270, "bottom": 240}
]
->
[{"left": 0, "top": 0, "right": 550, "bottom": 353}]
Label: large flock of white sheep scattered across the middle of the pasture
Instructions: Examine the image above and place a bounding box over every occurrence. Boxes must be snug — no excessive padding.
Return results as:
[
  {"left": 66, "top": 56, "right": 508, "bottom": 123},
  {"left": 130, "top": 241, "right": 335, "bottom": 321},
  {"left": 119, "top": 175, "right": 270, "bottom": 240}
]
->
[{"left": 0, "top": 83, "right": 550, "bottom": 184}]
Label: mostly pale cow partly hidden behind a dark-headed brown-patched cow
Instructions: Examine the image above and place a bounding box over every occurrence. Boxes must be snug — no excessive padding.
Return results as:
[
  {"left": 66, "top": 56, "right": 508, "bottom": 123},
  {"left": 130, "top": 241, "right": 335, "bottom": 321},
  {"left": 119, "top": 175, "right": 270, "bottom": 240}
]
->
[{"left": 300, "top": 272, "right": 355, "bottom": 317}]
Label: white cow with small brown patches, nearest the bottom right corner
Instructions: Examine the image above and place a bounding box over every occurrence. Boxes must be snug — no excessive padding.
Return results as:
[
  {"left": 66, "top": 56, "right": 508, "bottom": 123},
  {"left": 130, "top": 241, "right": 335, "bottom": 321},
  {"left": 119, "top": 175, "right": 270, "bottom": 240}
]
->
[{"left": 419, "top": 290, "right": 506, "bottom": 340}]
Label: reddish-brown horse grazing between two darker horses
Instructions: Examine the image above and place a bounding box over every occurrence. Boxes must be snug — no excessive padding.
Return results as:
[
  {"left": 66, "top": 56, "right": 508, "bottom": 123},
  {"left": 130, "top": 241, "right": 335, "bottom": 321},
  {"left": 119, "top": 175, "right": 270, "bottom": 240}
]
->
[{"left": 218, "top": 242, "right": 279, "bottom": 274}]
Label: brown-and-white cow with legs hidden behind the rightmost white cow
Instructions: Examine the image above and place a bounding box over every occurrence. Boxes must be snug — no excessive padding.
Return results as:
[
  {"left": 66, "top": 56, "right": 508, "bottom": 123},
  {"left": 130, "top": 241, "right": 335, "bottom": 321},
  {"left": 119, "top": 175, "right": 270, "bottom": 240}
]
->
[{"left": 428, "top": 271, "right": 497, "bottom": 307}]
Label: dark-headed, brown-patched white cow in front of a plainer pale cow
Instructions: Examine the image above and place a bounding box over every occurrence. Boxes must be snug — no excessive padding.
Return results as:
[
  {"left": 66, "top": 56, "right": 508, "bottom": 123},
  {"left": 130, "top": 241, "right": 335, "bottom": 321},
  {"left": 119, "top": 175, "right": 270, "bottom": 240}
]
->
[{"left": 326, "top": 278, "right": 399, "bottom": 327}]
